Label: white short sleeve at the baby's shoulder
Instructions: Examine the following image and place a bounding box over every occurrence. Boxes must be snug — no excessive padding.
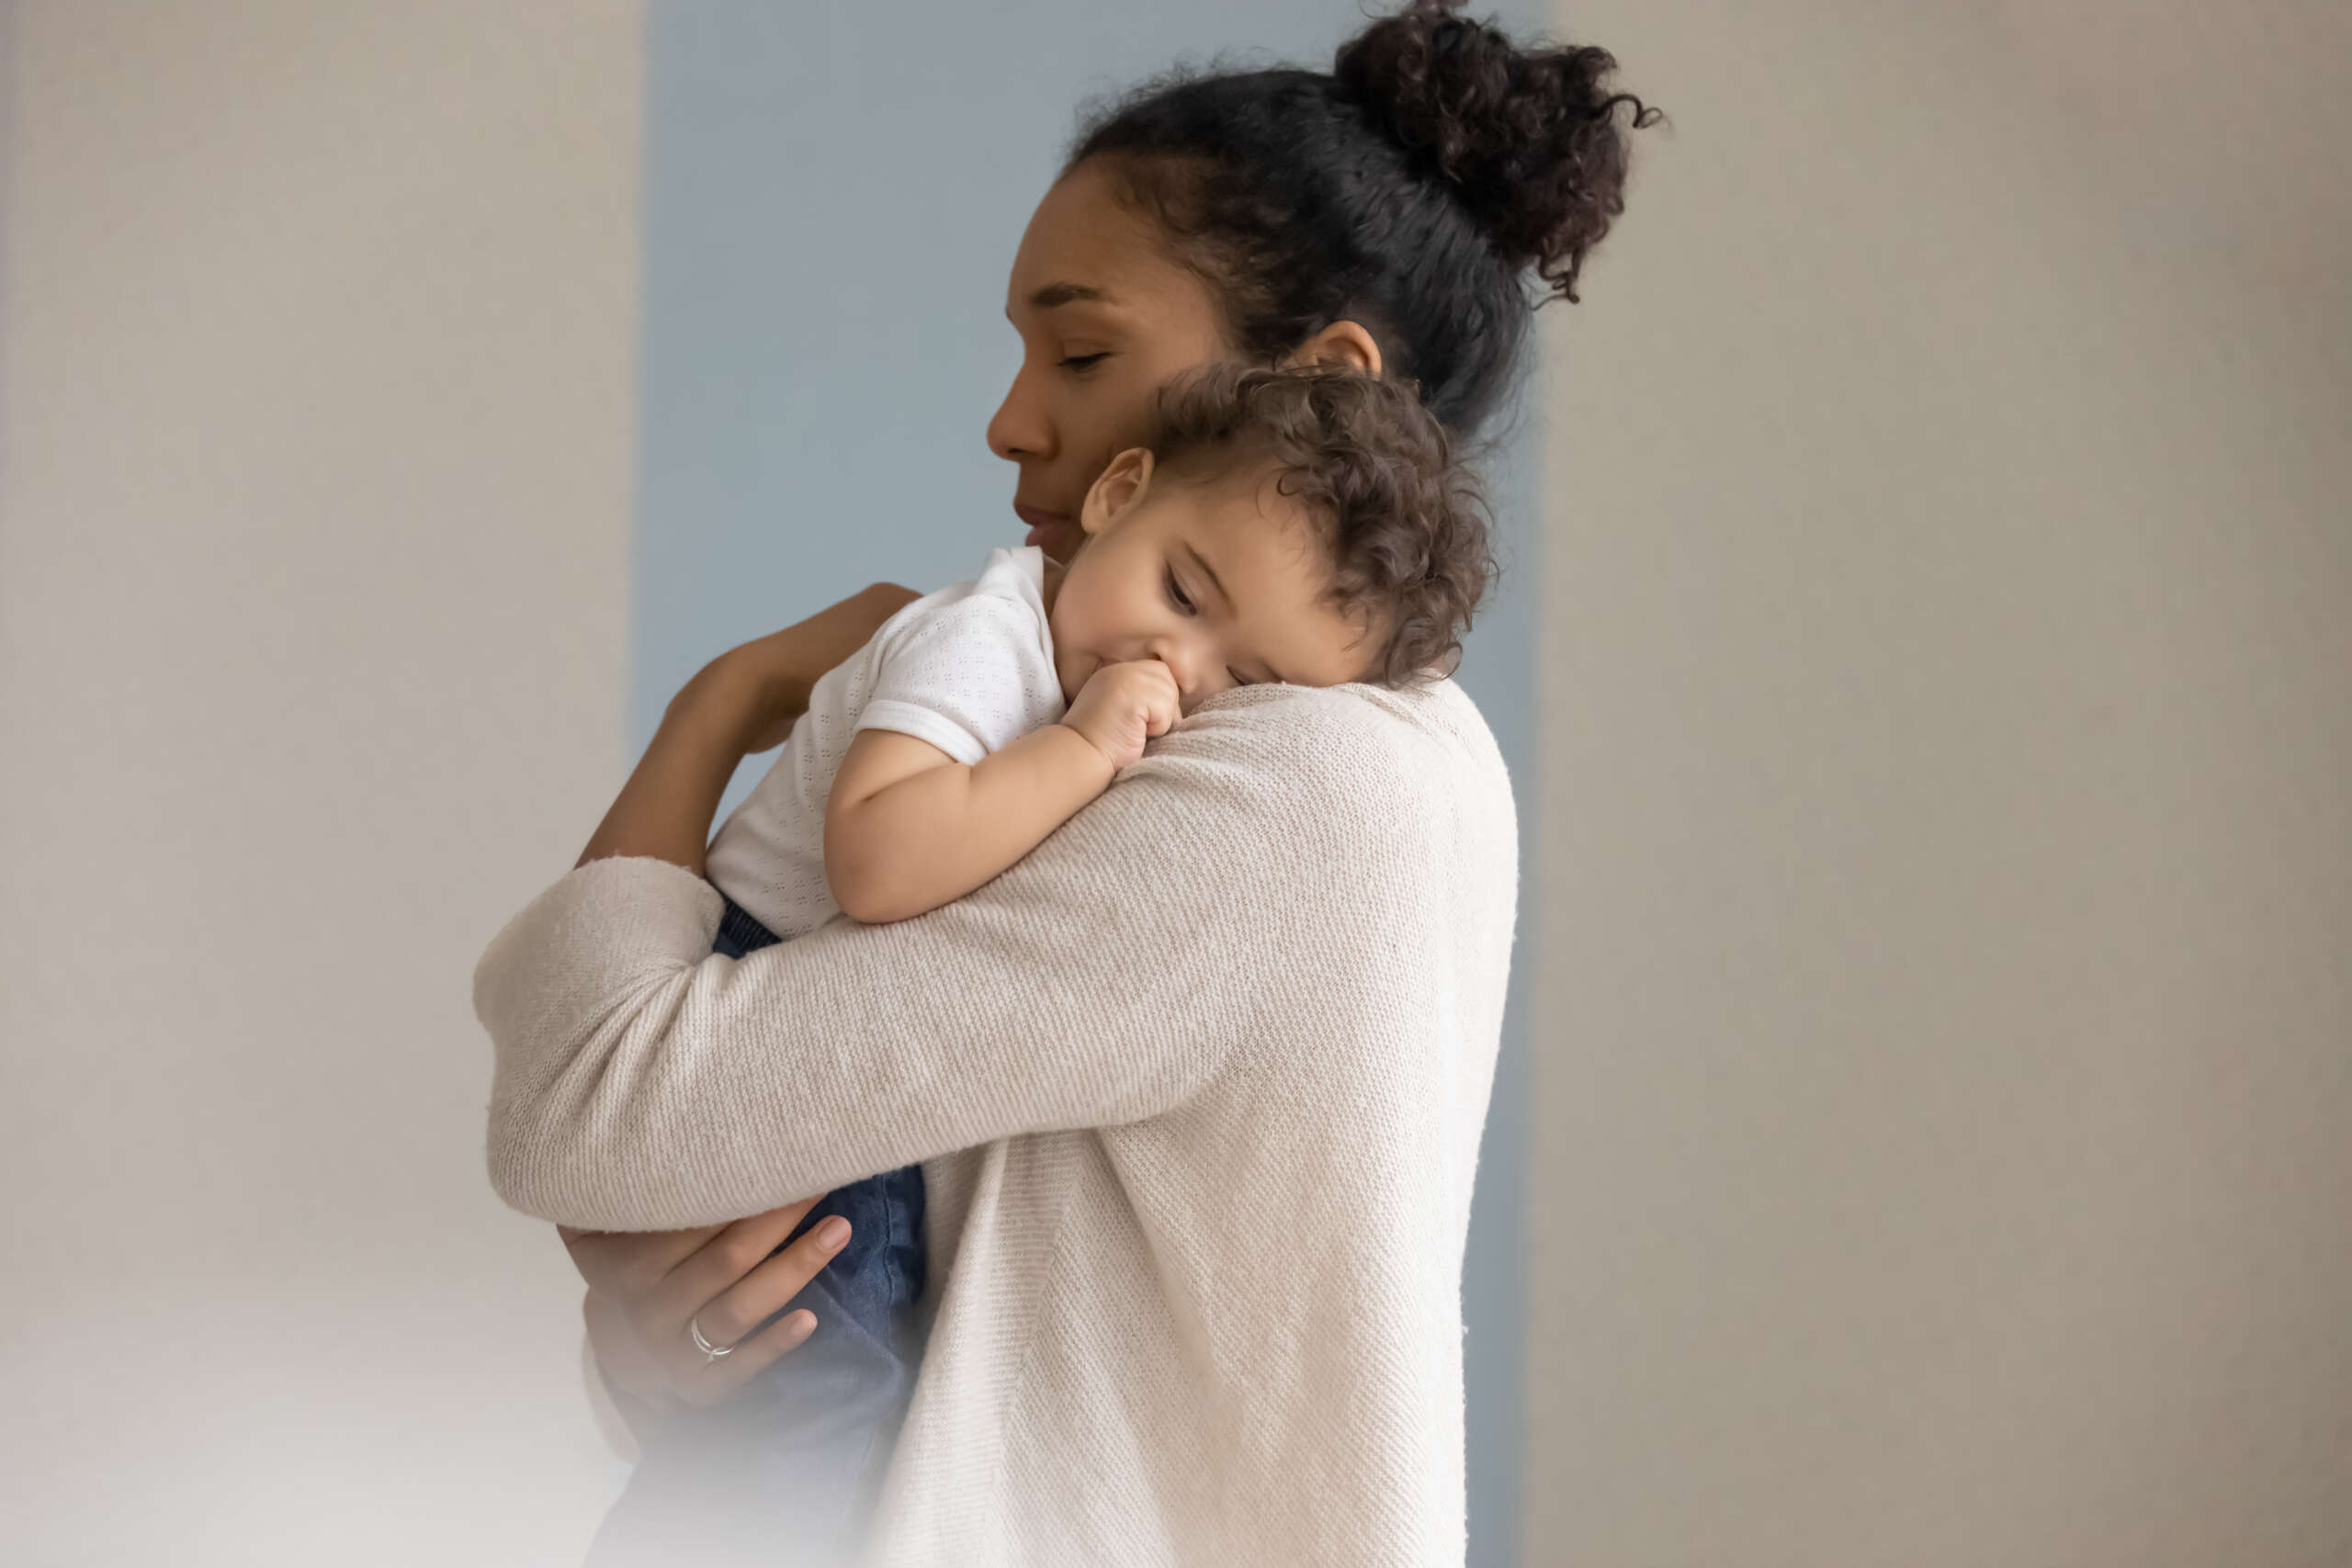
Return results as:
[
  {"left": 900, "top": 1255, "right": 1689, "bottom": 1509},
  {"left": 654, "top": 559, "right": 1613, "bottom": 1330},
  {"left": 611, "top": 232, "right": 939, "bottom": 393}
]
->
[{"left": 856, "top": 550, "right": 1063, "bottom": 764}]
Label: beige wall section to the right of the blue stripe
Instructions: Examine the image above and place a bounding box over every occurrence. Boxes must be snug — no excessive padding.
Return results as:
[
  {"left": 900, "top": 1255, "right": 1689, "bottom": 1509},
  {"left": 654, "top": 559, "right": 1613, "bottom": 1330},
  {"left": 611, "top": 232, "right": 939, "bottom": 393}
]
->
[{"left": 1526, "top": 0, "right": 2352, "bottom": 1568}]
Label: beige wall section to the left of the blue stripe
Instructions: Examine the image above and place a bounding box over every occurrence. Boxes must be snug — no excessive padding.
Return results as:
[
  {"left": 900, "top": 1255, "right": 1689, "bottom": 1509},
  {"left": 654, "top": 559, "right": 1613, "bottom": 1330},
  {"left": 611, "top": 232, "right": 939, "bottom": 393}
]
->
[{"left": 0, "top": 0, "right": 639, "bottom": 1568}]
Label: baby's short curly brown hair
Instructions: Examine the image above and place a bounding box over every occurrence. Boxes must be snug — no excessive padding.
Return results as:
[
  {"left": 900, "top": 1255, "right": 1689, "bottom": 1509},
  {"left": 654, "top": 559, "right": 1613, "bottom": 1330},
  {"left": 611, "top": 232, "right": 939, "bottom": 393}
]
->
[{"left": 1152, "top": 365, "right": 1496, "bottom": 686}]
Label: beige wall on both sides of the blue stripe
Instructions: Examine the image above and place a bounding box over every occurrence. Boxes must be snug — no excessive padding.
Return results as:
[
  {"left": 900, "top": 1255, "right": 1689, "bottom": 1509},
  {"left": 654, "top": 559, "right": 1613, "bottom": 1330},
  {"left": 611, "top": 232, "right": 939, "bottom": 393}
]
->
[{"left": 0, "top": 0, "right": 2352, "bottom": 1568}]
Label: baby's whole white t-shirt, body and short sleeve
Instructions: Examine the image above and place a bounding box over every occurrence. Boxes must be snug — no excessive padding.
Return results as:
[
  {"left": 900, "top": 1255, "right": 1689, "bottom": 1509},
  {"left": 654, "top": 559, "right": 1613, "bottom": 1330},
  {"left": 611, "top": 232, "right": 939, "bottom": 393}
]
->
[{"left": 708, "top": 546, "right": 1063, "bottom": 938}]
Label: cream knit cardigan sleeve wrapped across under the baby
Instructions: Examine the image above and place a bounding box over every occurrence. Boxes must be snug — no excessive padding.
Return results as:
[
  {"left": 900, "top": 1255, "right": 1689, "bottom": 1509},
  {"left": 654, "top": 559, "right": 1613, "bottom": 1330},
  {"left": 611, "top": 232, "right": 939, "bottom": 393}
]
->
[{"left": 473, "top": 701, "right": 1363, "bottom": 1229}]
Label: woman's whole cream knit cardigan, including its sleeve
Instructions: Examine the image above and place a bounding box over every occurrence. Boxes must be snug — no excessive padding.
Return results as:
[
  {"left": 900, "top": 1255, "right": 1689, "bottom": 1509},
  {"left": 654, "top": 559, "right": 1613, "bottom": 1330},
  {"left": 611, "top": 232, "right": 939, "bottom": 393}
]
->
[{"left": 473, "top": 682, "right": 1517, "bottom": 1568}]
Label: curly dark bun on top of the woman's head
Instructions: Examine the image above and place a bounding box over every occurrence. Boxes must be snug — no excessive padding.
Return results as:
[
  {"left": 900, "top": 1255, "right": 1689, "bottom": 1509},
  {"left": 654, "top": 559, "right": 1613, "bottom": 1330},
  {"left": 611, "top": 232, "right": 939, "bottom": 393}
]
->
[{"left": 1331, "top": 0, "right": 1660, "bottom": 301}]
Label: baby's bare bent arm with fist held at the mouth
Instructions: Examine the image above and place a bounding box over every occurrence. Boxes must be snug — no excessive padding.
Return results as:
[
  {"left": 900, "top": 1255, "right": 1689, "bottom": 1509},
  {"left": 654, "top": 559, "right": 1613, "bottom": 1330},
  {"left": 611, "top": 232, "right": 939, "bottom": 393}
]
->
[{"left": 826, "top": 659, "right": 1176, "bottom": 924}]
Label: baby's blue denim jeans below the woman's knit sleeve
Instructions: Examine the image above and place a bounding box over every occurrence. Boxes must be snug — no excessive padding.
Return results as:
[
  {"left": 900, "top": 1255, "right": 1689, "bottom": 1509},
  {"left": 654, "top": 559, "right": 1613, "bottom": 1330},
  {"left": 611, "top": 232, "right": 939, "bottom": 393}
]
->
[{"left": 588, "top": 898, "right": 924, "bottom": 1568}]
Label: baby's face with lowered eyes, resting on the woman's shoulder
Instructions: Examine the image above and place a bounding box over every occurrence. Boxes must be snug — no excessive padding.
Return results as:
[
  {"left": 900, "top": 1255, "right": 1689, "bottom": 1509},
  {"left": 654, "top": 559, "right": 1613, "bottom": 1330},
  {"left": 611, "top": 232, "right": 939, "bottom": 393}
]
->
[{"left": 1051, "top": 446, "right": 1371, "bottom": 712}]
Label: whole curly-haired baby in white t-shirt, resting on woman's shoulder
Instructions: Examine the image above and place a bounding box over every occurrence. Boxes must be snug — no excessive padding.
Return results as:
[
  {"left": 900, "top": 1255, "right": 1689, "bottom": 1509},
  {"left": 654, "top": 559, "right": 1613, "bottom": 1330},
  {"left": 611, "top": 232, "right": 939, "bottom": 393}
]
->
[{"left": 673, "top": 367, "right": 1491, "bottom": 1526}]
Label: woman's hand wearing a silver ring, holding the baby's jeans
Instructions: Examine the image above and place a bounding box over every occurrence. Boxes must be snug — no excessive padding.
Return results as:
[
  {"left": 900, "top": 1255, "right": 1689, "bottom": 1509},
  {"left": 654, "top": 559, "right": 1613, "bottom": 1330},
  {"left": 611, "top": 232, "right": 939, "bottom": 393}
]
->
[{"left": 555, "top": 1194, "right": 849, "bottom": 1425}]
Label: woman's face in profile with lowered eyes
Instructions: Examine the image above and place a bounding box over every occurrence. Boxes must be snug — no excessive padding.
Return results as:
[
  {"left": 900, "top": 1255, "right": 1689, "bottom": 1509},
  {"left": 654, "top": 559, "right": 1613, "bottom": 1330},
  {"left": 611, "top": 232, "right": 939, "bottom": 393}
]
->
[{"left": 988, "top": 164, "right": 1230, "bottom": 562}]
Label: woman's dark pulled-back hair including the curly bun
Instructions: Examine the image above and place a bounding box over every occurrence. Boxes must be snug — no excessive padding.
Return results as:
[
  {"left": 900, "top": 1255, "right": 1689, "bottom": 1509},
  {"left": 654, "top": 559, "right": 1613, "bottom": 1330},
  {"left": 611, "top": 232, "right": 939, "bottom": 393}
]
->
[{"left": 1063, "top": 0, "right": 1663, "bottom": 434}]
